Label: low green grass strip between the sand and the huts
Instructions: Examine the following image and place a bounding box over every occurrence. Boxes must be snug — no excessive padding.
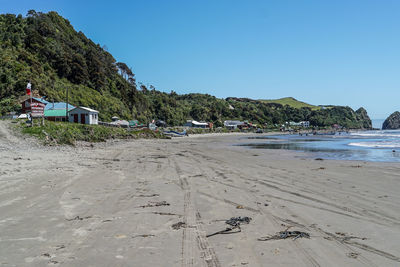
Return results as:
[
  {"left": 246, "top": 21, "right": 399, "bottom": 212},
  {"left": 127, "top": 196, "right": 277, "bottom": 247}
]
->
[{"left": 19, "top": 121, "right": 165, "bottom": 145}]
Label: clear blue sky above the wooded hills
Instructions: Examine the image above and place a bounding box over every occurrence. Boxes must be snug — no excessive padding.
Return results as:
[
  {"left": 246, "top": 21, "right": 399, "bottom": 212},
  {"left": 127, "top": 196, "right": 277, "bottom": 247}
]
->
[{"left": 0, "top": 0, "right": 400, "bottom": 118}]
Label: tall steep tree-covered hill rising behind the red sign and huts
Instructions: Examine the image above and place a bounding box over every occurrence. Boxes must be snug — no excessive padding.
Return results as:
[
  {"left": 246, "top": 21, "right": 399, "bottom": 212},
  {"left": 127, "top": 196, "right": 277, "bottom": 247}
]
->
[{"left": 0, "top": 10, "right": 140, "bottom": 119}]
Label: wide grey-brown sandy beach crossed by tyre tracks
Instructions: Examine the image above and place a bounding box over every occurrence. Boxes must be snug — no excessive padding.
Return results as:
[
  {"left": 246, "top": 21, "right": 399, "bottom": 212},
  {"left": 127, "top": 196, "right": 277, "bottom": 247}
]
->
[{"left": 0, "top": 122, "right": 400, "bottom": 266}]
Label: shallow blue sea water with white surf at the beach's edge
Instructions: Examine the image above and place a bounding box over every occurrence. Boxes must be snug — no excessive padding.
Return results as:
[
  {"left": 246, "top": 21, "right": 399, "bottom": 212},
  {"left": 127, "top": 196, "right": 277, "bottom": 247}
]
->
[{"left": 244, "top": 130, "right": 400, "bottom": 162}]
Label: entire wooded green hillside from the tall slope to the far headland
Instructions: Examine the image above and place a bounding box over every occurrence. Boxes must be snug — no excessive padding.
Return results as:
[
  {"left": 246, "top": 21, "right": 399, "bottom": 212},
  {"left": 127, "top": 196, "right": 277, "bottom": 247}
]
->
[{"left": 0, "top": 10, "right": 371, "bottom": 128}]
